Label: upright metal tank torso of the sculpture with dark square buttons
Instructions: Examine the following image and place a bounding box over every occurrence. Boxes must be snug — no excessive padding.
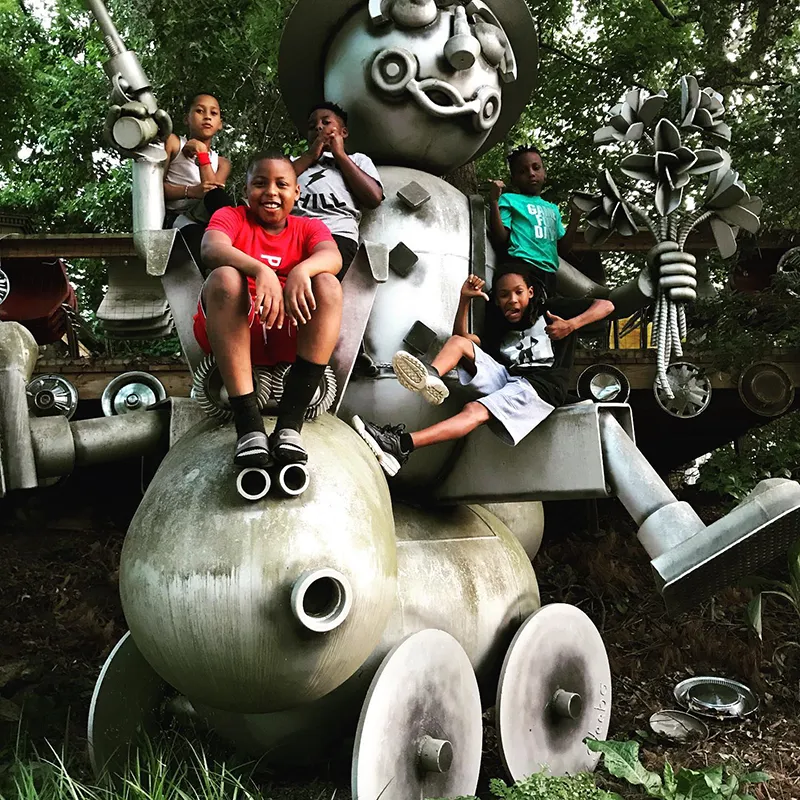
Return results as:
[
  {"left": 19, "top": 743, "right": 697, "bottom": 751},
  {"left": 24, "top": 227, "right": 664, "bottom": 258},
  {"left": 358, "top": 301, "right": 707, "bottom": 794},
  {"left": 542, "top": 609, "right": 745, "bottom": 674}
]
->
[{"left": 339, "top": 167, "right": 493, "bottom": 489}]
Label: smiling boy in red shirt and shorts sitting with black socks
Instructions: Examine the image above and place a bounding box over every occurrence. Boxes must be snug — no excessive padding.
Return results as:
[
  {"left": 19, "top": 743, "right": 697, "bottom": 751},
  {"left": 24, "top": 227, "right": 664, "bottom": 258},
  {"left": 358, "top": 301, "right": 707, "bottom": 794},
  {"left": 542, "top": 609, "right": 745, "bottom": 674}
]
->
[{"left": 194, "top": 152, "right": 342, "bottom": 467}]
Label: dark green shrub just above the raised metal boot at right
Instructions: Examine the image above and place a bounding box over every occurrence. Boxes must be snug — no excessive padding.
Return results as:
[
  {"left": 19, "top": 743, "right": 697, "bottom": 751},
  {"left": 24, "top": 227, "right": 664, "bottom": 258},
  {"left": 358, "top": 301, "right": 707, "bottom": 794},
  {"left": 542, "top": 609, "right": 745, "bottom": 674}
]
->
[{"left": 697, "top": 412, "right": 800, "bottom": 501}]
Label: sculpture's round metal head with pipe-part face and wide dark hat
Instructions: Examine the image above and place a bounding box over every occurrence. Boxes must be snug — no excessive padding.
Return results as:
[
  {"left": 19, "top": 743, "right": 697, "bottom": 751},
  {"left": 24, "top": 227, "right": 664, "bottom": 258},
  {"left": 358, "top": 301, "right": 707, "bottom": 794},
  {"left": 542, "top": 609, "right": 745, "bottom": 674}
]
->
[{"left": 280, "top": 0, "right": 537, "bottom": 174}]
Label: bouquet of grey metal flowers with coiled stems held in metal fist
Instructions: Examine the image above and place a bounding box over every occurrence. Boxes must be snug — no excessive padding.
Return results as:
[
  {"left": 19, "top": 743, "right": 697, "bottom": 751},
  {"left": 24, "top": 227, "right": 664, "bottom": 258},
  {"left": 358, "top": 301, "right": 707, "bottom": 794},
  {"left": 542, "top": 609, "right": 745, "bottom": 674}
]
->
[{"left": 575, "top": 75, "right": 762, "bottom": 399}]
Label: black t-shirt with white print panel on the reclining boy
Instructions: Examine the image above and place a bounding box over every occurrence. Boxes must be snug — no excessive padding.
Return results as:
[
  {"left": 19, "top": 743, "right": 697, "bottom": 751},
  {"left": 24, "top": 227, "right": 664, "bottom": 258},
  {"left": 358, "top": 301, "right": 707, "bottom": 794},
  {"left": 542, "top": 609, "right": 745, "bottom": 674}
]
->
[{"left": 482, "top": 297, "right": 593, "bottom": 406}]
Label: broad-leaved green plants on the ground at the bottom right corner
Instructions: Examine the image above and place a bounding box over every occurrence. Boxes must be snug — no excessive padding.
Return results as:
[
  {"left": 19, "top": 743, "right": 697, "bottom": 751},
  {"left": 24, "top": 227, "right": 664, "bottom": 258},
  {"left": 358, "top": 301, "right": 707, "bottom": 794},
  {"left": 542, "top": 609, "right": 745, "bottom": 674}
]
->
[{"left": 586, "top": 739, "right": 769, "bottom": 800}]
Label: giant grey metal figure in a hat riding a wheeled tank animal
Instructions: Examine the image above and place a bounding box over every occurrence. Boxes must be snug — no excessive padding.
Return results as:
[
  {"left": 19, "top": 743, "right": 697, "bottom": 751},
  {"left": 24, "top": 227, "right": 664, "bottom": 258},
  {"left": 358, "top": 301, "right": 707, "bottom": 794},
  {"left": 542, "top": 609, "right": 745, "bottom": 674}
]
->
[{"left": 0, "top": 0, "right": 800, "bottom": 800}]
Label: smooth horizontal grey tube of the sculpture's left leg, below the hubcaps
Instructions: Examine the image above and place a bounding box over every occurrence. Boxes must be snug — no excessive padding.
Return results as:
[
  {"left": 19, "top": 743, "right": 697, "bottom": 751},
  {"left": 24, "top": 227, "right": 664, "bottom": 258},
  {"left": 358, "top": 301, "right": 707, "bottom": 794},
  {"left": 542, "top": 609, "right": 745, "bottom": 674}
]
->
[{"left": 70, "top": 409, "right": 169, "bottom": 466}]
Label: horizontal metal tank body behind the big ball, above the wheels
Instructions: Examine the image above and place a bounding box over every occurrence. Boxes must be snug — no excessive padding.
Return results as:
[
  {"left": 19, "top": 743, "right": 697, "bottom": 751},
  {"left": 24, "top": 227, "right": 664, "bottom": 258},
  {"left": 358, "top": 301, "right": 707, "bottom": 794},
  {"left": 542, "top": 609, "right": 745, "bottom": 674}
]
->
[{"left": 197, "top": 504, "right": 541, "bottom": 763}]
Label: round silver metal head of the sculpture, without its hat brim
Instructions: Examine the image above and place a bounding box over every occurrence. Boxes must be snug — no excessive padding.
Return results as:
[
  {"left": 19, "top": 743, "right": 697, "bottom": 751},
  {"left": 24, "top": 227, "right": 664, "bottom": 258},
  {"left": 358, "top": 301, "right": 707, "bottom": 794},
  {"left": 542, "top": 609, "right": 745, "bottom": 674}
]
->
[{"left": 325, "top": 6, "right": 501, "bottom": 175}]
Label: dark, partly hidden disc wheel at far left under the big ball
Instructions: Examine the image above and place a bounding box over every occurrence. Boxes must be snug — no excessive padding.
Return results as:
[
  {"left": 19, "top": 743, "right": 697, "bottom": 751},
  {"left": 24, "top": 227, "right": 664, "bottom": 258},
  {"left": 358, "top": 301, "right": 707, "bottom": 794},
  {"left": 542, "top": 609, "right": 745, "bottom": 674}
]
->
[{"left": 89, "top": 631, "right": 169, "bottom": 777}]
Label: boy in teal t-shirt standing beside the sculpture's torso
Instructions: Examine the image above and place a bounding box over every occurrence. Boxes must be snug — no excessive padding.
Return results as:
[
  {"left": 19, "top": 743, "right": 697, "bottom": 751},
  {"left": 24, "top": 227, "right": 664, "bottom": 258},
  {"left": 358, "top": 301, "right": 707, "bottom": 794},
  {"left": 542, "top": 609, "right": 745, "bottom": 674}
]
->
[{"left": 489, "top": 146, "right": 566, "bottom": 296}]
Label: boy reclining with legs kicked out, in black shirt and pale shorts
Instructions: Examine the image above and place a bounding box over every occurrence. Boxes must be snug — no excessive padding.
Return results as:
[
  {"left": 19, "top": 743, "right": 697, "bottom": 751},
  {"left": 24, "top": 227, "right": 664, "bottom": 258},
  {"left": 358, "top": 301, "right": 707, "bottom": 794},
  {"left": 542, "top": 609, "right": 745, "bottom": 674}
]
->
[{"left": 353, "top": 267, "right": 614, "bottom": 475}]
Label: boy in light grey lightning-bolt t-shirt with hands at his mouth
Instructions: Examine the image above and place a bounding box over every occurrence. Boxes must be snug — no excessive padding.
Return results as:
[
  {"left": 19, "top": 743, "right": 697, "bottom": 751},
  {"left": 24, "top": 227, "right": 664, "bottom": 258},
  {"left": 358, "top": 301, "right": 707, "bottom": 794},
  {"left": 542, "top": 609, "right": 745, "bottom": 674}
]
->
[{"left": 292, "top": 103, "right": 383, "bottom": 280}]
